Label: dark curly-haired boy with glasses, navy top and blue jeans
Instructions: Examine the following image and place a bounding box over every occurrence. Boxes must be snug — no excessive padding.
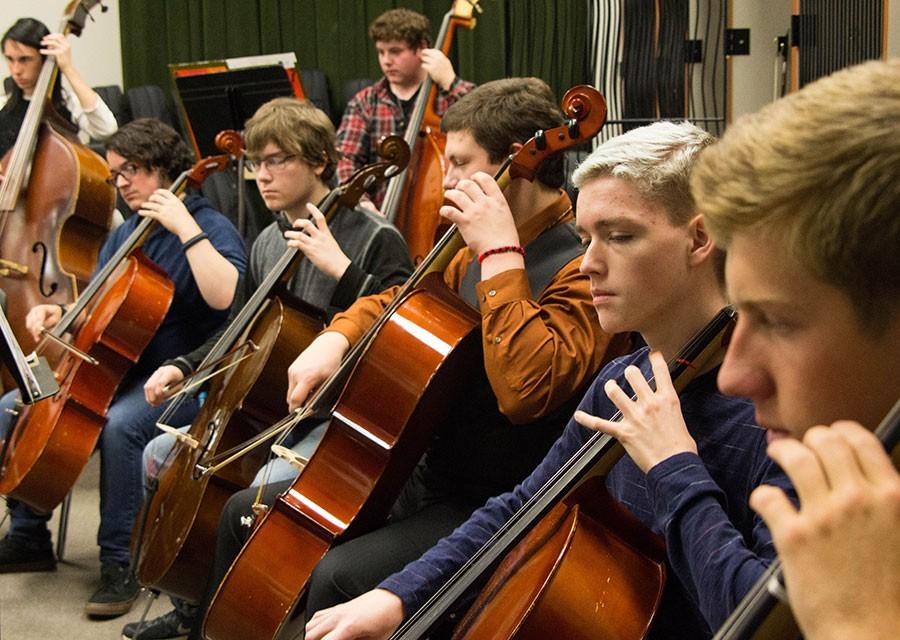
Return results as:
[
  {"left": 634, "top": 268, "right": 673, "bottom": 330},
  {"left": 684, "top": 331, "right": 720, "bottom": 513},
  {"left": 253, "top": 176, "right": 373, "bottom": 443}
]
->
[{"left": 0, "top": 118, "right": 246, "bottom": 617}]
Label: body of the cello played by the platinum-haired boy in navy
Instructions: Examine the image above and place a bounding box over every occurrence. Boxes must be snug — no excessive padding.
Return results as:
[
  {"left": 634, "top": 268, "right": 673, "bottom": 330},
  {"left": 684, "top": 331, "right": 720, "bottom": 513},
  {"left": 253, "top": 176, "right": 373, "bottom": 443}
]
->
[{"left": 453, "top": 476, "right": 666, "bottom": 640}]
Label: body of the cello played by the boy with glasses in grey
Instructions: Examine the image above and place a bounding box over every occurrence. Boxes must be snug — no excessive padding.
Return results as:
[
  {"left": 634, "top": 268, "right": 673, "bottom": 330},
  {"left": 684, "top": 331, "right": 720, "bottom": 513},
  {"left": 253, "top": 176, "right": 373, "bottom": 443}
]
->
[{"left": 135, "top": 297, "right": 323, "bottom": 602}]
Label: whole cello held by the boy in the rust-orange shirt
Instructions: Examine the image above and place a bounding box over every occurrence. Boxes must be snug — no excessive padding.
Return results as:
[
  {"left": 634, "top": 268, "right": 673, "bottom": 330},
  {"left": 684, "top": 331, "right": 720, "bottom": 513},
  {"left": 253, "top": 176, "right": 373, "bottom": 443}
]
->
[{"left": 203, "top": 86, "right": 606, "bottom": 640}]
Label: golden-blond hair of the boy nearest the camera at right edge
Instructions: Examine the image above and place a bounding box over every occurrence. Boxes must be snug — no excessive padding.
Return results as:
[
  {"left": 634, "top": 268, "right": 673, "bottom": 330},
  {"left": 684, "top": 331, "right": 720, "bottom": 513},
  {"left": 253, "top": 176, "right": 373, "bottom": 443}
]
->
[{"left": 691, "top": 59, "right": 900, "bottom": 331}]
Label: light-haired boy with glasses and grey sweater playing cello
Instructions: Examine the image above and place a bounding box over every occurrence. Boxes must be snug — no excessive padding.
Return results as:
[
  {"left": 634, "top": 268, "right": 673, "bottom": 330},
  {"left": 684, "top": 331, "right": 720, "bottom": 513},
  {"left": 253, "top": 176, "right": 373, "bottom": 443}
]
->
[{"left": 122, "top": 98, "right": 412, "bottom": 640}]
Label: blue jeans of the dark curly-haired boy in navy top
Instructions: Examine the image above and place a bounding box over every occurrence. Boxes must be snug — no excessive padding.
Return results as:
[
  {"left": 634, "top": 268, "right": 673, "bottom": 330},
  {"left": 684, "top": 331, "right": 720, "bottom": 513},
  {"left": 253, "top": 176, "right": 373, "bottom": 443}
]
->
[{"left": 0, "top": 376, "right": 198, "bottom": 565}]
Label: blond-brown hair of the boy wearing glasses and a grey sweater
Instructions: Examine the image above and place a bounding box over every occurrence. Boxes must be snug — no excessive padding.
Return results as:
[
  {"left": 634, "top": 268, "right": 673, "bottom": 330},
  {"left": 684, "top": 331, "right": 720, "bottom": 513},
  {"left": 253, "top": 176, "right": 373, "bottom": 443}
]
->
[{"left": 244, "top": 97, "right": 338, "bottom": 182}]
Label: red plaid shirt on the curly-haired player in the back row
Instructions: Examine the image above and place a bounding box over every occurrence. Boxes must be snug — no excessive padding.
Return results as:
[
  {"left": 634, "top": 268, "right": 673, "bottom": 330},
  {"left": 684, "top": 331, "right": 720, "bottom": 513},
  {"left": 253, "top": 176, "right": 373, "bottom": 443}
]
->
[{"left": 337, "top": 78, "right": 475, "bottom": 207}]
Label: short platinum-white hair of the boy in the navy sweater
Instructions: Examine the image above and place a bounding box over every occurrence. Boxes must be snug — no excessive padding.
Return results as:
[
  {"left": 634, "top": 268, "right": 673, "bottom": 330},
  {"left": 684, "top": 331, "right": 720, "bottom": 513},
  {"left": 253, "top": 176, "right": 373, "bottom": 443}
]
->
[{"left": 572, "top": 122, "right": 715, "bottom": 225}]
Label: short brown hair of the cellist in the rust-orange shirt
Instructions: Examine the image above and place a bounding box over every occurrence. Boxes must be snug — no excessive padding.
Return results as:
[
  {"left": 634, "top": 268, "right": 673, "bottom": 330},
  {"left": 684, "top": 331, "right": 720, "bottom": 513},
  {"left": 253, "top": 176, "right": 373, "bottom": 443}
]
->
[{"left": 441, "top": 78, "right": 565, "bottom": 188}]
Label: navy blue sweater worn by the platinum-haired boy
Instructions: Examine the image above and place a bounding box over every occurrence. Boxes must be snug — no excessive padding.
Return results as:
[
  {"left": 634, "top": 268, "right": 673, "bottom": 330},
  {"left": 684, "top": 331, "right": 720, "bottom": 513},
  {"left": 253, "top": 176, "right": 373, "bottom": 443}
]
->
[{"left": 379, "top": 348, "right": 793, "bottom": 638}]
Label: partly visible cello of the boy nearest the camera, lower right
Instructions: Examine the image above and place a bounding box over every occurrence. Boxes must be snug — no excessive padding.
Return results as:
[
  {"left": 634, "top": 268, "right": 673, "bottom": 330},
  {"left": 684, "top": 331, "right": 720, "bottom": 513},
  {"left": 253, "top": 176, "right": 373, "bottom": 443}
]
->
[{"left": 713, "top": 400, "right": 900, "bottom": 640}]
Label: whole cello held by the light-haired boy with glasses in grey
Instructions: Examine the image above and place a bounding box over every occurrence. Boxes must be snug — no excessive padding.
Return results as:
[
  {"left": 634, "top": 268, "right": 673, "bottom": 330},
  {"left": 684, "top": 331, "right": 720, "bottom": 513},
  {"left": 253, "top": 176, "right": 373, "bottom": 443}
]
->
[{"left": 132, "top": 136, "right": 409, "bottom": 602}]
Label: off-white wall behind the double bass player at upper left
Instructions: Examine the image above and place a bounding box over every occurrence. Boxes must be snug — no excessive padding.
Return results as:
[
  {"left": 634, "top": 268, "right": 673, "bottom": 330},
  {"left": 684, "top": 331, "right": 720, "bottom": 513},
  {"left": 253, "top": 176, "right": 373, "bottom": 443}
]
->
[{"left": 0, "top": 0, "right": 122, "bottom": 92}]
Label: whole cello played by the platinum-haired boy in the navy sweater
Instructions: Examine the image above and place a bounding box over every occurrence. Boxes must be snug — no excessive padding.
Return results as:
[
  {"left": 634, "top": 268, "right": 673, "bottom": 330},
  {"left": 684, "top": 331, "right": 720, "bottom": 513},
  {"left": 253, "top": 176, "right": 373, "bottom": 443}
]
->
[{"left": 392, "top": 307, "right": 735, "bottom": 640}]
